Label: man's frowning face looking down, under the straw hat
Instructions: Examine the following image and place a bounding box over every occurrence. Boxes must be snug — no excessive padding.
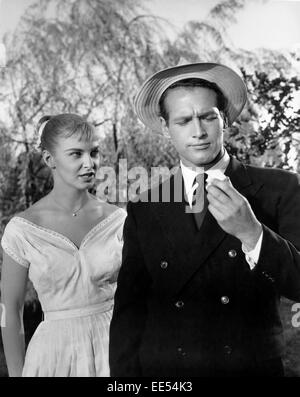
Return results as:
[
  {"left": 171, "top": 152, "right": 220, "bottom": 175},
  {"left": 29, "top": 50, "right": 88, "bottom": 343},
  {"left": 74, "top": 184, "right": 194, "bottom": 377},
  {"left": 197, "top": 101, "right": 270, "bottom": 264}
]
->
[{"left": 161, "top": 87, "right": 224, "bottom": 167}]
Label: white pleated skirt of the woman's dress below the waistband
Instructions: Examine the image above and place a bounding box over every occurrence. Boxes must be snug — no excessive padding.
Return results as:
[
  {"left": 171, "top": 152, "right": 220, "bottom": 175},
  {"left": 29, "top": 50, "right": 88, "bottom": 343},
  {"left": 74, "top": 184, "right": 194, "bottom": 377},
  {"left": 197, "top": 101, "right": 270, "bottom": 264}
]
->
[{"left": 22, "top": 310, "right": 112, "bottom": 377}]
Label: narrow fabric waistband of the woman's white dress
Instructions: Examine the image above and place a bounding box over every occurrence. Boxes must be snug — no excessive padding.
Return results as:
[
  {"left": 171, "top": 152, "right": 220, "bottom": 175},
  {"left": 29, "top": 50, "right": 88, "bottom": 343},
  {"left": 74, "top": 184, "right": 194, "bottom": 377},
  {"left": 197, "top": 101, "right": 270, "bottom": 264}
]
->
[{"left": 44, "top": 300, "right": 114, "bottom": 321}]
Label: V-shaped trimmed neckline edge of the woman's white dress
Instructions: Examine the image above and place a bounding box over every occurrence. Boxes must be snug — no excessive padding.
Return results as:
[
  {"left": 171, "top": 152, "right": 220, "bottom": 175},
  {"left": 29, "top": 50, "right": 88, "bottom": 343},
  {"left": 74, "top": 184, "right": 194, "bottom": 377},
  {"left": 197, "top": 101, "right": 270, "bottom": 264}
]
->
[{"left": 12, "top": 208, "right": 124, "bottom": 251}]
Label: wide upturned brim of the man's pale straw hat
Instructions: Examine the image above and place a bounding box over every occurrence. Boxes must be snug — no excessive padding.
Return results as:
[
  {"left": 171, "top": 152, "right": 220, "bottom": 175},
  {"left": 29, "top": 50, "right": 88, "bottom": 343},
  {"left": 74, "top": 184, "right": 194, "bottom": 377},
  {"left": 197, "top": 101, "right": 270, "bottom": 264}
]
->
[{"left": 134, "top": 63, "right": 247, "bottom": 132}]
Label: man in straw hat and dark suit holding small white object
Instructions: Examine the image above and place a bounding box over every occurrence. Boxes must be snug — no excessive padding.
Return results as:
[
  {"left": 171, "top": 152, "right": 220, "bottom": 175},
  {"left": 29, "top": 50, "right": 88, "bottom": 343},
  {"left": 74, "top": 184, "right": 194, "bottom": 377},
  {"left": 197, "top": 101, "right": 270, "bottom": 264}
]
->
[{"left": 110, "top": 63, "right": 300, "bottom": 377}]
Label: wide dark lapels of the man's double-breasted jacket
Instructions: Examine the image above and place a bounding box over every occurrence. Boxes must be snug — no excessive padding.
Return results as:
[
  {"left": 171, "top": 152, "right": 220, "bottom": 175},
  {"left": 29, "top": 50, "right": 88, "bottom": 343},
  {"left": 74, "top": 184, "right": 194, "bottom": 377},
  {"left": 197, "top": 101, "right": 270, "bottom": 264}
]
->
[{"left": 152, "top": 158, "right": 259, "bottom": 294}]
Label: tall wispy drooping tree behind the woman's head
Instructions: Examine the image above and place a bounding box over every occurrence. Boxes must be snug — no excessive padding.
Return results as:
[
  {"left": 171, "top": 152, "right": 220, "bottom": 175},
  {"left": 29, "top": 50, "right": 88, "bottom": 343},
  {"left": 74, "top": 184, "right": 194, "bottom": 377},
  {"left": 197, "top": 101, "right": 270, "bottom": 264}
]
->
[{"left": 0, "top": 0, "right": 172, "bottom": 207}]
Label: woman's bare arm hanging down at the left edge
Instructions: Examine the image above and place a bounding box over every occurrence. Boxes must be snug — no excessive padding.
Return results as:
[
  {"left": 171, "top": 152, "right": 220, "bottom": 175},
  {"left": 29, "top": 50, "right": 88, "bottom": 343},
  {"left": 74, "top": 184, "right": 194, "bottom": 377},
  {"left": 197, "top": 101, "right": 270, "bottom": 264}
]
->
[{"left": 1, "top": 252, "right": 28, "bottom": 377}]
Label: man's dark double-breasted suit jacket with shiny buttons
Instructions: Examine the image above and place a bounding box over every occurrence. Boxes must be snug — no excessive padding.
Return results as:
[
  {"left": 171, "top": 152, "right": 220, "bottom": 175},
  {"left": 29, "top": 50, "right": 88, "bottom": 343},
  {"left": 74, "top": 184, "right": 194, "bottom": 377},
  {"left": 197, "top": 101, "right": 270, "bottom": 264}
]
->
[{"left": 110, "top": 158, "right": 300, "bottom": 376}]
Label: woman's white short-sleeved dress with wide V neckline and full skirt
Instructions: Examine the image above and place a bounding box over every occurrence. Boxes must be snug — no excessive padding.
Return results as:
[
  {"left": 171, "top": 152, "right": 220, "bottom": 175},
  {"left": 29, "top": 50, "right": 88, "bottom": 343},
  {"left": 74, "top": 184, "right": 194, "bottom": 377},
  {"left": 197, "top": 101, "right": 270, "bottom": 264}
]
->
[{"left": 1, "top": 208, "right": 126, "bottom": 377}]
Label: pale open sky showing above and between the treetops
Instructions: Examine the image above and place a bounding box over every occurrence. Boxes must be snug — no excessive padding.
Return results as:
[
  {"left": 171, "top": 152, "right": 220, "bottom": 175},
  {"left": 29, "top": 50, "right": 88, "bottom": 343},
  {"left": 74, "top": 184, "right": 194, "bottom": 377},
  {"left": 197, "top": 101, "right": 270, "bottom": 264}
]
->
[{"left": 0, "top": 0, "right": 300, "bottom": 50}]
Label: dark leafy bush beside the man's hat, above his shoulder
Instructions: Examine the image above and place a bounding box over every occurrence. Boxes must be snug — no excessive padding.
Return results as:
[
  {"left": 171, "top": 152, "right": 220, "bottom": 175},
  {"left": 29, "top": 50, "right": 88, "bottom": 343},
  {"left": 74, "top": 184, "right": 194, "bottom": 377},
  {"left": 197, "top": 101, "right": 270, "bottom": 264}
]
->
[{"left": 223, "top": 70, "right": 300, "bottom": 171}]
